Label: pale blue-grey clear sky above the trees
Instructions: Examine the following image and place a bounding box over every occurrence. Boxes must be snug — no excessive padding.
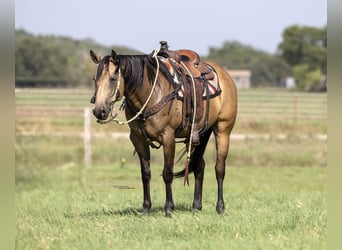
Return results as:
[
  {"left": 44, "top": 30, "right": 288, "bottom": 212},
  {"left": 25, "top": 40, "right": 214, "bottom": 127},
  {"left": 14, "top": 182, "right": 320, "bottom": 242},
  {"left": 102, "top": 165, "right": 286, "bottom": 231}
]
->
[{"left": 15, "top": 0, "right": 327, "bottom": 55}]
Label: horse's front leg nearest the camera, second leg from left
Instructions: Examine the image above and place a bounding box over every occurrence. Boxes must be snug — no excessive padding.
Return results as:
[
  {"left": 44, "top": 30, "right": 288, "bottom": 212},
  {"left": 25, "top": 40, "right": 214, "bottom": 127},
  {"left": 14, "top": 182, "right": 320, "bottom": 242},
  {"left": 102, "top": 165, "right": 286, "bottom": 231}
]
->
[{"left": 163, "top": 136, "right": 175, "bottom": 217}]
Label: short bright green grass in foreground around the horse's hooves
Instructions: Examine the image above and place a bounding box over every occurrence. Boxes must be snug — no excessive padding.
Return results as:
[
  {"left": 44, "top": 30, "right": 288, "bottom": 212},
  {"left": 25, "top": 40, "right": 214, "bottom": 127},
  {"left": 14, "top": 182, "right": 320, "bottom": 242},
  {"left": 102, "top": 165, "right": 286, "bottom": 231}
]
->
[{"left": 15, "top": 165, "right": 327, "bottom": 249}]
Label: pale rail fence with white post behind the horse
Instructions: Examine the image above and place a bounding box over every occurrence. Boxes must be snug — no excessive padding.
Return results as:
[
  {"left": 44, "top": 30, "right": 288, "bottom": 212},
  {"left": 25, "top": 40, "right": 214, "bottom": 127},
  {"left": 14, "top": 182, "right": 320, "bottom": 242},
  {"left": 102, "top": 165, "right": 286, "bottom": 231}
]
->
[{"left": 16, "top": 89, "right": 327, "bottom": 166}]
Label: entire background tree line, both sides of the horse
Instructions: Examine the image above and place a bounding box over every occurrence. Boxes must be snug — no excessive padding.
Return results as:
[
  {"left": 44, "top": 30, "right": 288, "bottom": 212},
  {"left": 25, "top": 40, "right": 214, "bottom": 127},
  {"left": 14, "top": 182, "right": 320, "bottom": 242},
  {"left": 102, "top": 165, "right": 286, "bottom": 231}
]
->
[{"left": 15, "top": 25, "right": 327, "bottom": 91}]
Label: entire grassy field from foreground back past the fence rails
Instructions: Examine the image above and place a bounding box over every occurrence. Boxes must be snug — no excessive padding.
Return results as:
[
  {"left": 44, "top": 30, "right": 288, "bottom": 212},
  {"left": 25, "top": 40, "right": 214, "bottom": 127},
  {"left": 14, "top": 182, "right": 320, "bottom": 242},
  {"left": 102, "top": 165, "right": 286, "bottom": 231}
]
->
[{"left": 15, "top": 90, "right": 327, "bottom": 250}]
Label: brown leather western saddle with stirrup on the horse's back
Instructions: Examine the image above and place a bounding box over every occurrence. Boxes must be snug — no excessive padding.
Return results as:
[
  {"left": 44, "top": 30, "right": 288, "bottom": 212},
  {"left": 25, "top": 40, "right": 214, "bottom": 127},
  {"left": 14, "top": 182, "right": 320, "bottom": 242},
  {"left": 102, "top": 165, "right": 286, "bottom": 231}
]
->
[{"left": 158, "top": 41, "right": 215, "bottom": 146}]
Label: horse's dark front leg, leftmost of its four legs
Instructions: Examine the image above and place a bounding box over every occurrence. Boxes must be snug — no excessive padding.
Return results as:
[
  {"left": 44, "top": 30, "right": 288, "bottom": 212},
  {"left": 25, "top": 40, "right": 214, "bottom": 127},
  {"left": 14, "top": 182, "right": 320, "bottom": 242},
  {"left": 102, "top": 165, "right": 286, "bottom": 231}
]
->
[{"left": 130, "top": 134, "right": 152, "bottom": 214}]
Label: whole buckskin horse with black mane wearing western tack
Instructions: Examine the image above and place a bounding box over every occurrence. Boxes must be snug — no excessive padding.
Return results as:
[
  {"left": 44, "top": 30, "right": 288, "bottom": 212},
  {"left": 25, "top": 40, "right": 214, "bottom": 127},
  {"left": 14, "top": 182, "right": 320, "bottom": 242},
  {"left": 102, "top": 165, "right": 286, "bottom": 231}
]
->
[{"left": 90, "top": 42, "right": 237, "bottom": 216}]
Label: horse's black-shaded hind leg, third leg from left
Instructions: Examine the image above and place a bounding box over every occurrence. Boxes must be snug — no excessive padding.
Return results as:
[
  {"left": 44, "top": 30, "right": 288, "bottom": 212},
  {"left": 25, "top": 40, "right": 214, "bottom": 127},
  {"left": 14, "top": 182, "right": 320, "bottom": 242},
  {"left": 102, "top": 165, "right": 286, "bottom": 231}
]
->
[{"left": 189, "top": 130, "right": 212, "bottom": 210}]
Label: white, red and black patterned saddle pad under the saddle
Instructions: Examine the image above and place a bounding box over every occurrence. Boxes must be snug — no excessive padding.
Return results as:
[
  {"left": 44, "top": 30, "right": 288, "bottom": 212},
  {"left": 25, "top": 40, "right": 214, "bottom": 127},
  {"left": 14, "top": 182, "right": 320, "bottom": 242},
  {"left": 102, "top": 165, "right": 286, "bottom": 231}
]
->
[{"left": 159, "top": 56, "right": 221, "bottom": 99}]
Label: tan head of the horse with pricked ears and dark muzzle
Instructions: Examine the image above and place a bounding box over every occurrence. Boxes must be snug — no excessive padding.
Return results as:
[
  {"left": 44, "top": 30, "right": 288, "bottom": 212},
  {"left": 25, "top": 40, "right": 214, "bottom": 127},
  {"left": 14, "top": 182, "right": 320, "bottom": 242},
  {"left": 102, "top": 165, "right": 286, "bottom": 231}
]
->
[{"left": 90, "top": 50, "right": 124, "bottom": 121}]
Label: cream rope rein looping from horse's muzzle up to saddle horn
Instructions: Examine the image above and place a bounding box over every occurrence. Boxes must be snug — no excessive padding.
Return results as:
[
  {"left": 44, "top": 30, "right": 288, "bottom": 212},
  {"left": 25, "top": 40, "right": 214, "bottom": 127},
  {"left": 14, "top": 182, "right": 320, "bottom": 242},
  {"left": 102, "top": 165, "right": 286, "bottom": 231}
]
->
[{"left": 97, "top": 49, "right": 159, "bottom": 125}]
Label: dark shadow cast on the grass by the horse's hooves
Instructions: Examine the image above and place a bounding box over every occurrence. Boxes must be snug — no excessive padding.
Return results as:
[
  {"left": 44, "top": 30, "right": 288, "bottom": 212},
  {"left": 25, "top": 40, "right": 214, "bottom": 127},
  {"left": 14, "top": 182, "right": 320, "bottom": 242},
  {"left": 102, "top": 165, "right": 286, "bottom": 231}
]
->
[{"left": 64, "top": 203, "right": 192, "bottom": 219}]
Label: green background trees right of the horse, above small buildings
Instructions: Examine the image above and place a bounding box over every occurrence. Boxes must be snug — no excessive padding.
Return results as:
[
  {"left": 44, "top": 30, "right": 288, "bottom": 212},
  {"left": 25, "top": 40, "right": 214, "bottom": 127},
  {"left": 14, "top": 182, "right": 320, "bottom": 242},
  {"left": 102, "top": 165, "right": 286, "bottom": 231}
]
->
[{"left": 208, "top": 25, "right": 327, "bottom": 91}]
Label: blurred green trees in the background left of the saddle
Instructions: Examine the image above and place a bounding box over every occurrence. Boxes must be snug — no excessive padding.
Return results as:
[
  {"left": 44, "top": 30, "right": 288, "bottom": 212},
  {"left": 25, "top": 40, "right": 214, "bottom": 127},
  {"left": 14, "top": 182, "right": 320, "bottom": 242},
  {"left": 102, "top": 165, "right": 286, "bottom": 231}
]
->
[{"left": 15, "top": 30, "right": 141, "bottom": 87}]
